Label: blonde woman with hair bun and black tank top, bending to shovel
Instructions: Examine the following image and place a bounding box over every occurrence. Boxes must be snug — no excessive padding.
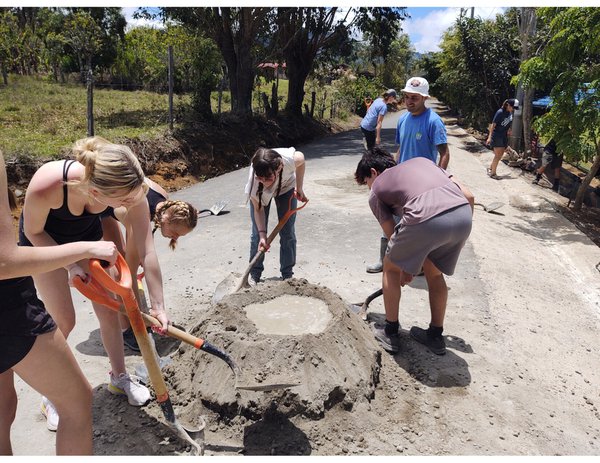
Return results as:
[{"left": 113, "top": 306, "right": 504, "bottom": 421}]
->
[{"left": 19, "top": 137, "right": 168, "bottom": 429}]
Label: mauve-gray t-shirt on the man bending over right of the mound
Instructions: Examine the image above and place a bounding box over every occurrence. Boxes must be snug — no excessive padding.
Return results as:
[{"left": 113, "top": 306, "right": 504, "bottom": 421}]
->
[{"left": 369, "top": 157, "right": 468, "bottom": 225}]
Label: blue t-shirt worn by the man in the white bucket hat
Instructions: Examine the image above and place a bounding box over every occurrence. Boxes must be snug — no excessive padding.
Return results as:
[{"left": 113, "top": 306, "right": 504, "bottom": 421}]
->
[{"left": 396, "top": 108, "right": 448, "bottom": 164}]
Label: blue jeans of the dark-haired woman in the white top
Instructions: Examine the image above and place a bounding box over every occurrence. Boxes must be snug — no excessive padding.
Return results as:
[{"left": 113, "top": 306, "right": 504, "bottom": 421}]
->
[{"left": 250, "top": 188, "right": 298, "bottom": 281}]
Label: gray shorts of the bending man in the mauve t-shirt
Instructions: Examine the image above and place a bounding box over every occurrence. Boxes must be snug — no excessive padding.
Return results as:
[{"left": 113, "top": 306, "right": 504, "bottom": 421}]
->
[{"left": 386, "top": 204, "right": 473, "bottom": 275}]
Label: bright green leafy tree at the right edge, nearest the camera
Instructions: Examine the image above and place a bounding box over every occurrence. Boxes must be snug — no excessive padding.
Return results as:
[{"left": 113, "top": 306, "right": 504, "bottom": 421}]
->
[{"left": 518, "top": 7, "right": 600, "bottom": 210}]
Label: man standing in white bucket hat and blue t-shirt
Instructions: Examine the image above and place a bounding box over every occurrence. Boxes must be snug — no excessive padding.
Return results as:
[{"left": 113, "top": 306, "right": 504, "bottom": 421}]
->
[{"left": 367, "top": 77, "right": 450, "bottom": 273}]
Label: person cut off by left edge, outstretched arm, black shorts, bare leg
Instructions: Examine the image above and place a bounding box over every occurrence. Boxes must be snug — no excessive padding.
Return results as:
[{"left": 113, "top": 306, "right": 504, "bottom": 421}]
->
[{"left": 0, "top": 152, "right": 117, "bottom": 455}]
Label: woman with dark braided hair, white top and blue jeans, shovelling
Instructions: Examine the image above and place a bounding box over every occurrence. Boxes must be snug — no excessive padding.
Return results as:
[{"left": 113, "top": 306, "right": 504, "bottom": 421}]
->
[{"left": 246, "top": 147, "right": 307, "bottom": 284}]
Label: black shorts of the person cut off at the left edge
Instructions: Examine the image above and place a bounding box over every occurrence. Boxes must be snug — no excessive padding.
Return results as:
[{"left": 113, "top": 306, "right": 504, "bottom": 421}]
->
[{"left": 0, "top": 277, "right": 56, "bottom": 373}]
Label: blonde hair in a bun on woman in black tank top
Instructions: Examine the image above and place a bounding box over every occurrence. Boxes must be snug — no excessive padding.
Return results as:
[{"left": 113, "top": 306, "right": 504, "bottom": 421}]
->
[{"left": 68, "top": 137, "right": 148, "bottom": 197}]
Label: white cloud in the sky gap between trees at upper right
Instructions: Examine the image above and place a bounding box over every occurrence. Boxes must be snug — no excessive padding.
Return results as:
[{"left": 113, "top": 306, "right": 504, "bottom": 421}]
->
[{"left": 402, "top": 8, "right": 504, "bottom": 53}]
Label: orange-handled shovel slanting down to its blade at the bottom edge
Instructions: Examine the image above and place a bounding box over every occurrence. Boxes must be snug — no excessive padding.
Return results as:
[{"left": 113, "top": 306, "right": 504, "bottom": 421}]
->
[{"left": 73, "top": 255, "right": 204, "bottom": 455}]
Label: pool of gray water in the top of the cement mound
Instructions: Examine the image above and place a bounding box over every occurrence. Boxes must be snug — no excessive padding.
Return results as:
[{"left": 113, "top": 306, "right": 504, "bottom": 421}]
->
[{"left": 244, "top": 294, "right": 332, "bottom": 336}]
